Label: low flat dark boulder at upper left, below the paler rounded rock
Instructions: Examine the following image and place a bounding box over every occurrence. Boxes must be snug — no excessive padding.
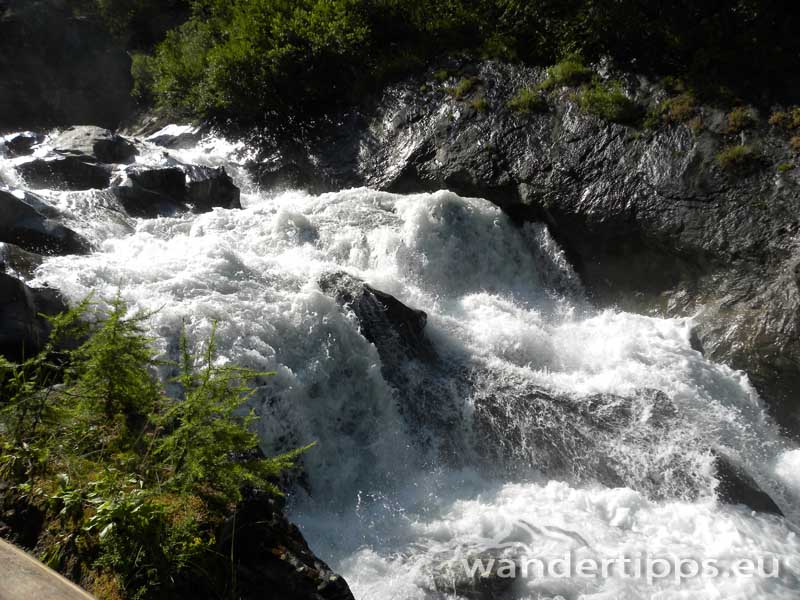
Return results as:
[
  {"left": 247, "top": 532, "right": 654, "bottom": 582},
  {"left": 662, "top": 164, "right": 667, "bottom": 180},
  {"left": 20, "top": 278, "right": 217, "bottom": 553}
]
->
[{"left": 17, "top": 156, "right": 111, "bottom": 190}]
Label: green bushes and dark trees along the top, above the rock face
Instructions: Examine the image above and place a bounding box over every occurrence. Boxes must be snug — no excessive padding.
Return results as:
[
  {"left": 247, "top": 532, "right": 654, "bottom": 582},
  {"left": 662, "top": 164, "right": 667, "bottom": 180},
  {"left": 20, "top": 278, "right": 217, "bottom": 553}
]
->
[{"left": 128, "top": 0, "right": 800, "bottom": 123}]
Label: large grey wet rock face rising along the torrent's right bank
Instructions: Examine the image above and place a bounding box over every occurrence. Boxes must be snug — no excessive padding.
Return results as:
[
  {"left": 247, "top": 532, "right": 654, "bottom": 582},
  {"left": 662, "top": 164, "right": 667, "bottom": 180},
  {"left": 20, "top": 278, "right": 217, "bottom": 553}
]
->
[{"left": 248, "top": 62, "right": 800, "bottom": 435}]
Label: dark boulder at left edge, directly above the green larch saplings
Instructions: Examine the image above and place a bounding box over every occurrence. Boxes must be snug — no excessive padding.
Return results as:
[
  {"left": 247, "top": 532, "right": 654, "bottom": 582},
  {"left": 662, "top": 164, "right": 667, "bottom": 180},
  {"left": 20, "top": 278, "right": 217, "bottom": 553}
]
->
[{"left": 0, "top": 273, "right": 67, "bottom": 361}]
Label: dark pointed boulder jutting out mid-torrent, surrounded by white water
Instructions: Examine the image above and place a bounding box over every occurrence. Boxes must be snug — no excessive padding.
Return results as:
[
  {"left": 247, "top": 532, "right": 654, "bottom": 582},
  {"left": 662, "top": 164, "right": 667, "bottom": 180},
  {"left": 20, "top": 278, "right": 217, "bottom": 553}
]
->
[{"left": 319, "top": 271, "right": 436, "bottom": 360}]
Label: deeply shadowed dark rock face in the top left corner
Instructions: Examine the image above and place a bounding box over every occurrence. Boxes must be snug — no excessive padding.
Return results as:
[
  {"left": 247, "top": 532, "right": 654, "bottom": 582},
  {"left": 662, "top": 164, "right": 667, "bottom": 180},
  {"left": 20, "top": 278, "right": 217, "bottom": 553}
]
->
[{"left": 0, "top": 0, "right": 133, "bottom": 132}]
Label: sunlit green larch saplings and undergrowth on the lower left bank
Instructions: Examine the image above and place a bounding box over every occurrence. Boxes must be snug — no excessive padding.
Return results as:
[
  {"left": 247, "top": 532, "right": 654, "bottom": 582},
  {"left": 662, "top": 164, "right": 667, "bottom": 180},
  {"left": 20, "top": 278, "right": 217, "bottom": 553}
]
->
[{"left": 0, "top": 298, "right": 309, "bottom": 598}]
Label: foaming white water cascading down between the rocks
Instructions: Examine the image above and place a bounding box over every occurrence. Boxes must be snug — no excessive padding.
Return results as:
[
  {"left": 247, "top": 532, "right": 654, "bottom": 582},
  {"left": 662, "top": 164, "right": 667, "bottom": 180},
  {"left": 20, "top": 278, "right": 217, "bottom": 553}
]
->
[{"left": 6, "top": 129, "right": 800, "bottom": 600}]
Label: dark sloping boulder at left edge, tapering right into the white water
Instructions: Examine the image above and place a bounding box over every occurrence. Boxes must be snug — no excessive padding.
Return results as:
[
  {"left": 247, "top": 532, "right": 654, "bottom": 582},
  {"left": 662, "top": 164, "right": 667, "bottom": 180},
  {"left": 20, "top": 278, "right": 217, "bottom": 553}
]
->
[{"left": 0, "top": 189, "right": 91, "bottom": 254}]
